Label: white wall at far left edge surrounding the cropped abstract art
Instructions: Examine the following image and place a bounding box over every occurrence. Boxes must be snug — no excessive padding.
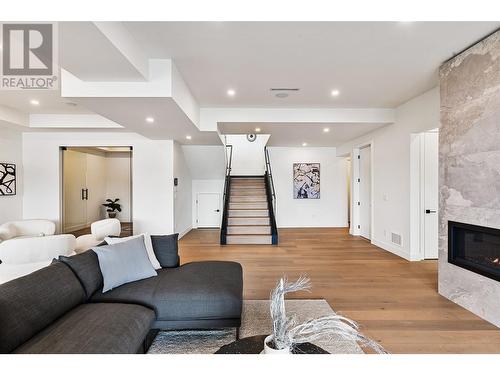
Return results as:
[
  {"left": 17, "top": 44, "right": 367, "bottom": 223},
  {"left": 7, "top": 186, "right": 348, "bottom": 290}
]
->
[{"left": 0, "top": 124, "right": 24, "bottom": 224}]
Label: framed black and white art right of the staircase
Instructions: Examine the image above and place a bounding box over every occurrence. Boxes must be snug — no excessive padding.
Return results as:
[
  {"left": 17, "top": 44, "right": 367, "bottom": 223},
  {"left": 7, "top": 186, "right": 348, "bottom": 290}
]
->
[{"left": 293, "top": 163, "right": 320, "bottom": 199}]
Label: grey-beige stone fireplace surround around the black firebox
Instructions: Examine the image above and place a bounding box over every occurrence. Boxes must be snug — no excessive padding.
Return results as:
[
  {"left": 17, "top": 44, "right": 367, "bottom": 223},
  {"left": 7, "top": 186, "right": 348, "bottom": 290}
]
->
[{"left": 438, "top": 31, "right": 500, "bottom": 327}]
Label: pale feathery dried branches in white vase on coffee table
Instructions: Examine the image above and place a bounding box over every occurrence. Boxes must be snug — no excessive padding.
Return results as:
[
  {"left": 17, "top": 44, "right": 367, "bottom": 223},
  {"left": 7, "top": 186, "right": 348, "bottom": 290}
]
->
[{"left": 270, "top": 276, "right": 387, "bottom": 353}]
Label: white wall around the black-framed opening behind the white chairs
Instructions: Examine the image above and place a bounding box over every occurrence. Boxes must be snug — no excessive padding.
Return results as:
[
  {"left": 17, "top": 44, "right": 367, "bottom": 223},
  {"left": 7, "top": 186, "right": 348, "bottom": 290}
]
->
[{"left": 23, "top": 133, "right": 174, "bottom": 234}]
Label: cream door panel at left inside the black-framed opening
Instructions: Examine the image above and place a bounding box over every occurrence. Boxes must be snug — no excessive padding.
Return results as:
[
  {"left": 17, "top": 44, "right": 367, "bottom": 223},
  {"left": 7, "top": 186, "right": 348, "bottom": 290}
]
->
[{"left": 63, "top": 150, "right": 87, "bottom": 232}]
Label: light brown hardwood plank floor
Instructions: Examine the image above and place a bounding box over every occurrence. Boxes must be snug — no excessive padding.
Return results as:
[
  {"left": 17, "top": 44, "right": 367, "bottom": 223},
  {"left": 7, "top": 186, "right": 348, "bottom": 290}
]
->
[{"left": 179, "top": 228, "right": 500, "bottom": 353}]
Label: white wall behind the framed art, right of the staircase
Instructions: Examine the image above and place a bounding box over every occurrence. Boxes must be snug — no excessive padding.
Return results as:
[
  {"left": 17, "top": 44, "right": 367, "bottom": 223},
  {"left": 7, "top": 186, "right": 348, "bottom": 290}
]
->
[{"left": 269, "top": 147, "right": 347, "bottom": 228}]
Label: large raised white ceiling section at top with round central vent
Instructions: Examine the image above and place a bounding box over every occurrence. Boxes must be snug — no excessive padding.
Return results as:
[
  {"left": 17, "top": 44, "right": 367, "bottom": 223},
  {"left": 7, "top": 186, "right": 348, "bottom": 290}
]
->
[{"left": 125, "top": 22, "right": 500, "bottom": 107}]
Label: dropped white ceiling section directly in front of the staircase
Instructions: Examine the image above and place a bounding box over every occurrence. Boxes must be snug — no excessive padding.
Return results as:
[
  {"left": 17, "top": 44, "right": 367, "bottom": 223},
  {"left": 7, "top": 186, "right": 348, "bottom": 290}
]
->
[{"left": 219, "top": 122, "right": 387, "bottom": 147}]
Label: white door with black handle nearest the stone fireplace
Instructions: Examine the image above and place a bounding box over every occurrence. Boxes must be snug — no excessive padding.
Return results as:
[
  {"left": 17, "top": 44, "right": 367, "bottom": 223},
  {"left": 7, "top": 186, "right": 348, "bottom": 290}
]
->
[{"left": 423, "top": 132, "right": 439, "bottom": 259}]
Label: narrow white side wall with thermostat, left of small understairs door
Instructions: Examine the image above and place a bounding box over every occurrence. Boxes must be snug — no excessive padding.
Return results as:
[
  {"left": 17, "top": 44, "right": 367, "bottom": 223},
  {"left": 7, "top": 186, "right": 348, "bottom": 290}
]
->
[{"left": 172, "top": 142, "right": 193, "bottom": 237}]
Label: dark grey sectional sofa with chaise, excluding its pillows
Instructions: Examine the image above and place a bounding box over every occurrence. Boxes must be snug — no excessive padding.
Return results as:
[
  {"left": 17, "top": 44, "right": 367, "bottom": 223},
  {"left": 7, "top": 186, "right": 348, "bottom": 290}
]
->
[{"left": 0, "top": 245, "right": 243, "bottom": 354}]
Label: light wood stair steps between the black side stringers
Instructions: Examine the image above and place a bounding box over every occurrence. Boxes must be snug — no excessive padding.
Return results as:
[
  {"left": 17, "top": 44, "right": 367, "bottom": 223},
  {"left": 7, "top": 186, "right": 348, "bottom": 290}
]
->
[{"left": 226, "top": 176, "right": 272, "bottom": 245}]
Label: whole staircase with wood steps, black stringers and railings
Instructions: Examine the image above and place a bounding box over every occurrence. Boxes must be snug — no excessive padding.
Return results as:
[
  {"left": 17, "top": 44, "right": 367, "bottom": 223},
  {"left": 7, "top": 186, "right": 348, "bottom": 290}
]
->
[{"left": 220, "top": 145, "right": 278, "bottom": 245}]
